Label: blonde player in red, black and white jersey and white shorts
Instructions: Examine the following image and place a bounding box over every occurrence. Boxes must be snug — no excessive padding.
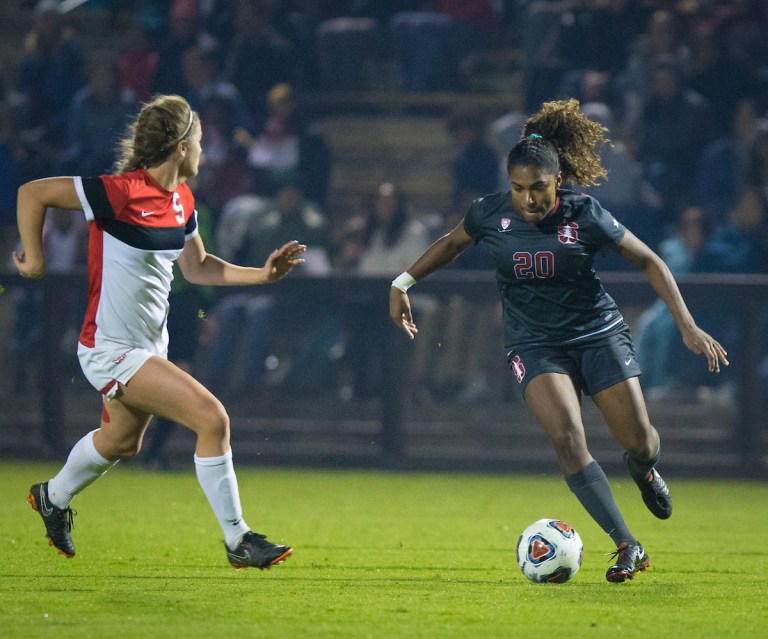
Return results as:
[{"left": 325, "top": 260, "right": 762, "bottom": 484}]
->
[{"left": 13, "top": 96, "right": 306, "bottom": 569}]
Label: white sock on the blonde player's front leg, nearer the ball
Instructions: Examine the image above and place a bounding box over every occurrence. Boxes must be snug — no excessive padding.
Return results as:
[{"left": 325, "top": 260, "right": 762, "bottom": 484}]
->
[{"left": 195, "top": 450, "right": 250, "bottom": 550}]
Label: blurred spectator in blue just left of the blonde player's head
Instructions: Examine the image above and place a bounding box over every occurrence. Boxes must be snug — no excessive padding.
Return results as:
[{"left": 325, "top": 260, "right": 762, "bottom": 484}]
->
[{"left": 56, "top": 56, "right": 137, "bottom": 175}]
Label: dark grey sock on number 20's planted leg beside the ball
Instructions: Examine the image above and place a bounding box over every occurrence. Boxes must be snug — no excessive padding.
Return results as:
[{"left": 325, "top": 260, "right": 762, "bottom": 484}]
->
[{"left": 565, "top": 461, "right": 635, "bottom": 546}]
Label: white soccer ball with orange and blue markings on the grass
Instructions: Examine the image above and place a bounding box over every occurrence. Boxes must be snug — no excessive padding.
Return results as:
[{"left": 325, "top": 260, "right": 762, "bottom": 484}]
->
[{"left": 517, "top": 519, "right": 584, "bottom": 584}]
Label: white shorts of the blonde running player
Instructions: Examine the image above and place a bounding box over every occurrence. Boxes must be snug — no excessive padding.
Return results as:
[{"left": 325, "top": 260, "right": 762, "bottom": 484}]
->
[{"left": 77, "top": 343, "right": 168, "bottom": 400}]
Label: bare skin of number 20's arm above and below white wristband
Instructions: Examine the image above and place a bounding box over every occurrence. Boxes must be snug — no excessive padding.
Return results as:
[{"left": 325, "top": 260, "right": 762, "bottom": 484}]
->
[{"left": 389, "top": 221, "right": 472, "bottom": 339}]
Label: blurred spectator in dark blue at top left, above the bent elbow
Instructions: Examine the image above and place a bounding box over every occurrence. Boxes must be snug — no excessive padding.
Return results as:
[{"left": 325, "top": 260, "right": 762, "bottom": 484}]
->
[{"left": 17, "top": 0, "right": 85, "bottom": 174}]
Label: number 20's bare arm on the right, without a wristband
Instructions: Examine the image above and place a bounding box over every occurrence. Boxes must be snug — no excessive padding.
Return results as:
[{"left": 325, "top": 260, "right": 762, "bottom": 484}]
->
[{"left": 616, "top": 231, "right": 729, "bottom": 373}]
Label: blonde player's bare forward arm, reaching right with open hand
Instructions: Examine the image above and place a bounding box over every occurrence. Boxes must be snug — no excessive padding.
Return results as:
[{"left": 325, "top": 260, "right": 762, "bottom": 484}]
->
[{"left": 179, "top": 235, "right": 307, "bottom": 286}]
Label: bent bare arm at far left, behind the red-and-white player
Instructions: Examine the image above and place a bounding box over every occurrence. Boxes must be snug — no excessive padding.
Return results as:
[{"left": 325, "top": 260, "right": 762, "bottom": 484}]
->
[{"left": 12, "top": 177, "right": 83, "bottom": 279}]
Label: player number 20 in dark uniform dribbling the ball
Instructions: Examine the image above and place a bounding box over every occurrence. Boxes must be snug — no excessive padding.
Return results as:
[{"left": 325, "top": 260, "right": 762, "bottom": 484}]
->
[{"left": 390, "top": 100, "right": 728, "bottom": 582}]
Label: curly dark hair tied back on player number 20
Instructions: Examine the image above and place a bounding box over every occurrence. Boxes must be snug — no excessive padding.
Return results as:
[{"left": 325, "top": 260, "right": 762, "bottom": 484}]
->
[{"left": 507, "top": 99, "right": 611, "bottom": 186}]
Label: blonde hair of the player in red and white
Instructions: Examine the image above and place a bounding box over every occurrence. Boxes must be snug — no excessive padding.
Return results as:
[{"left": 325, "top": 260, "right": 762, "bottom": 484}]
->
[{"left": 115, "top": 95, "right": 199, "bottom": 173}]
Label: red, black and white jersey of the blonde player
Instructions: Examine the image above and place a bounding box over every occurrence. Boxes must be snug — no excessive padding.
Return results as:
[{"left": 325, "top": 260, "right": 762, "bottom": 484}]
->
[{"left": 74, "top": 169, "right": 197, "bottom": 354}]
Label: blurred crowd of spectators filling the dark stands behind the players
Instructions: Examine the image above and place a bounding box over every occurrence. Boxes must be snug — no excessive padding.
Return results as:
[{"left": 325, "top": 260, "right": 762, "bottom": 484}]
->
[{"left": 0, "top": 0, "right": 768, "bottom": 408}]
